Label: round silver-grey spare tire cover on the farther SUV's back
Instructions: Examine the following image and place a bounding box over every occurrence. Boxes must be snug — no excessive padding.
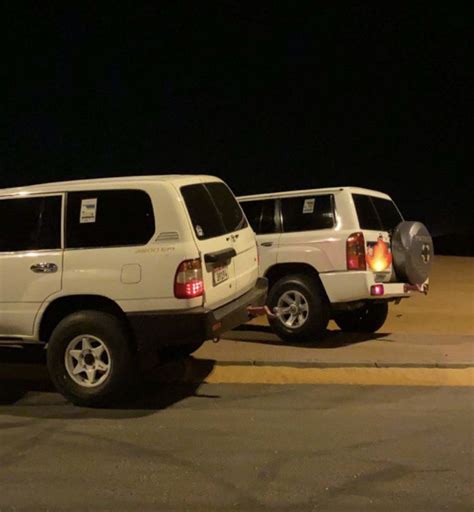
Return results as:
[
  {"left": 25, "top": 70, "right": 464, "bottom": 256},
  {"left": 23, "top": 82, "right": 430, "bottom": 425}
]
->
[{"left": 392, "top": 221, "right": 434, "bottom": 284}]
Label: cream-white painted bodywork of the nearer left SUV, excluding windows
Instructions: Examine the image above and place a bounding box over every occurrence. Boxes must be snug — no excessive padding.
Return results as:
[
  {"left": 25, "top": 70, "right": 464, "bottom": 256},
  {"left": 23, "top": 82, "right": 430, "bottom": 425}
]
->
[{"left": 0, "top": 175, "right": 258, "bottom": 343}]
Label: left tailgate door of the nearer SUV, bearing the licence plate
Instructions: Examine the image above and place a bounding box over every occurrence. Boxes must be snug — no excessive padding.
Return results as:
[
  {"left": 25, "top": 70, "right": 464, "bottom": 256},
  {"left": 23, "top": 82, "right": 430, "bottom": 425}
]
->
[{"left": 180, "top": 183, "right": 239, "bottom": 309}]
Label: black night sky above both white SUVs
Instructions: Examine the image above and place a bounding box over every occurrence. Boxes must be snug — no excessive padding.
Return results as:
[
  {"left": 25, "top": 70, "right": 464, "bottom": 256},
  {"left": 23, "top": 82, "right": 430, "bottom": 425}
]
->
[{"left": 0, "top": 2, "right": 474, "bottom": 235}]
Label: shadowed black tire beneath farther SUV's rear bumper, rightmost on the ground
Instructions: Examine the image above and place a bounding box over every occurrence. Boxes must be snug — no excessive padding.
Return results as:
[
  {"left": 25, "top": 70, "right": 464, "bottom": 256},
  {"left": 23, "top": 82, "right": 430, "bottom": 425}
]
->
[{"left": 334, "top": 302, "right": 388, "bottom": 332}]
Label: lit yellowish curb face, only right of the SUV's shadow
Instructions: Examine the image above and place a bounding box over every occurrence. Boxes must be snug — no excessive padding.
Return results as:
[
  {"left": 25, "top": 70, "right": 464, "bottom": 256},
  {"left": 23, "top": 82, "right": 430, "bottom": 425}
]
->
[{"left": 197, "top": 366, "right": 474, "bottom": 387}]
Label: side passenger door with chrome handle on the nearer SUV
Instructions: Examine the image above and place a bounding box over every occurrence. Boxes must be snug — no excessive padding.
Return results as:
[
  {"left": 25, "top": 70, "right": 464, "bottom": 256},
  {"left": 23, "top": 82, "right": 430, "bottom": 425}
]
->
[{"left": 0, "top": 195, "right": 63, "bottom": 337}]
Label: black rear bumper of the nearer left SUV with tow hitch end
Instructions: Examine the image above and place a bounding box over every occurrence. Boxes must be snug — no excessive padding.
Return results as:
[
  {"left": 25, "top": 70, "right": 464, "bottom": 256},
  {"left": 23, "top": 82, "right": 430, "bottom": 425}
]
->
[{"left": 127, "top": 278, "right": 268, "bottom": 350}]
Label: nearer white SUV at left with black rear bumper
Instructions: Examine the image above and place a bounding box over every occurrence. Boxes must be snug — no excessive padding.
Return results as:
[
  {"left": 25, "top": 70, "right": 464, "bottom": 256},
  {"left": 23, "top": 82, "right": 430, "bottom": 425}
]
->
[{"left": 0, "top": 176, "right": 267, "bottom": 405}]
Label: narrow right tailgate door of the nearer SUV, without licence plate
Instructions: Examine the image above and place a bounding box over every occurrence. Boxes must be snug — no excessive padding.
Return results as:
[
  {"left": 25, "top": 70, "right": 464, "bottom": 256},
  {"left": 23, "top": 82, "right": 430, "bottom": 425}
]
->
[{"left": 206, "top": 182, "right": 258, "bottom": 295}]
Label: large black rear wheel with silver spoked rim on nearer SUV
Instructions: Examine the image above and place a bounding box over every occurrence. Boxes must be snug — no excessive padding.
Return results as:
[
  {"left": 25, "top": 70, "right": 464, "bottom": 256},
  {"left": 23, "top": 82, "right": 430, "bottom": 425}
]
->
[{"left": 47, "top": 311, "right": 136, "bottom": 407}]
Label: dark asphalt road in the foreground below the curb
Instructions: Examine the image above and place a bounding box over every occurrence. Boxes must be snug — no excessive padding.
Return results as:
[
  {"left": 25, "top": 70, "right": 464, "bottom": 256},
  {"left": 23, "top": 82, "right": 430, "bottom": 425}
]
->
[{"left": 0, "top": 381, "right": 474, "bottom": 511}]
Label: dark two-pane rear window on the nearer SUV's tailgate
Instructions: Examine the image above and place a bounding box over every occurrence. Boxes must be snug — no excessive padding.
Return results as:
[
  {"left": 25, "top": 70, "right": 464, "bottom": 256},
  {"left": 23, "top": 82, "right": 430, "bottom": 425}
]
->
[{"left": 181, "top": 182, "right": 248, "bottom": 240}]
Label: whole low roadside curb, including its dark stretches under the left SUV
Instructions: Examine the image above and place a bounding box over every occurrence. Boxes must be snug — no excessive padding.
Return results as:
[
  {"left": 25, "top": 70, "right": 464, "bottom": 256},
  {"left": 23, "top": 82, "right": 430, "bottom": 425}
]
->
[{"left": 0, "top": 358, "right": 474, "bottom": 390}]
